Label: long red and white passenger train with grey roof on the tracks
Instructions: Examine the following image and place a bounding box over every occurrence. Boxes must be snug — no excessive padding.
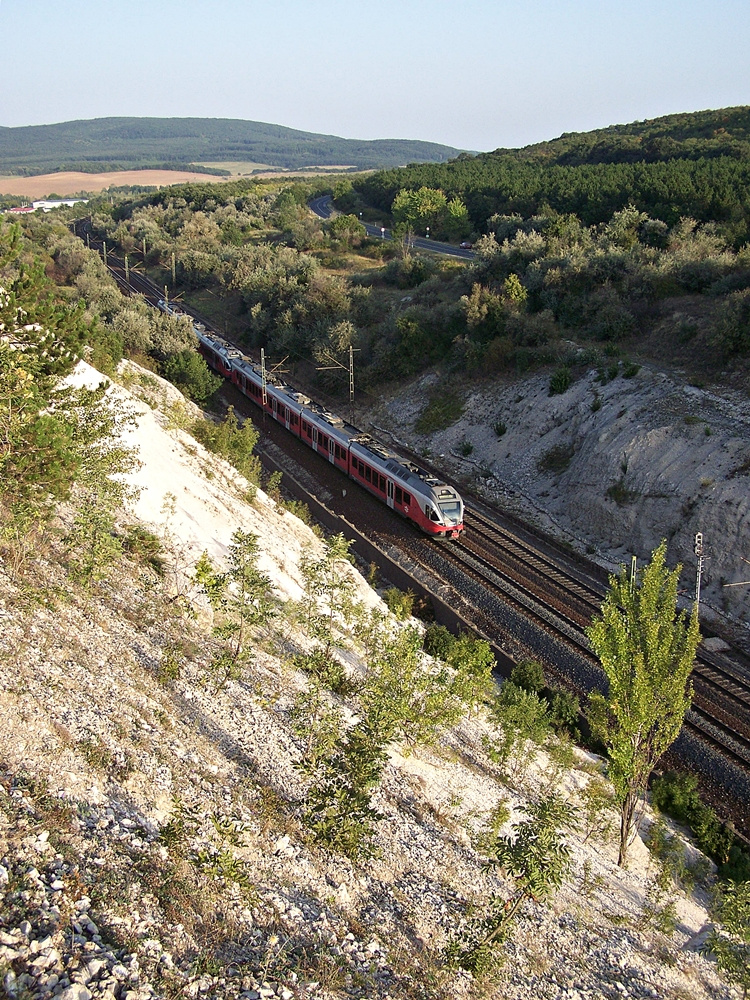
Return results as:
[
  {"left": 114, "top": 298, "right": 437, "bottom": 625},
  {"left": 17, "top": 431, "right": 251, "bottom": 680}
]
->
[{"left": 159, "top": 302, "right": 464, "bottom": 539}]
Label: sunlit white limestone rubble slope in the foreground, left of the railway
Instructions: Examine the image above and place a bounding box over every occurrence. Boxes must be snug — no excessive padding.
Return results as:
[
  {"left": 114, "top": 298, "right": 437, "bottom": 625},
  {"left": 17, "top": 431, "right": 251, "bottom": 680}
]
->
[{"left": 0, "top": 368, "right": 733, "bottom": 1000}]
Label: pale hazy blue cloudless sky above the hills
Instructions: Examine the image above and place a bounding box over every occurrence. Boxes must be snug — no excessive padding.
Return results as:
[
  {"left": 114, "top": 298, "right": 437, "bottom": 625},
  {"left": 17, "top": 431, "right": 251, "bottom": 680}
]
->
[{"left": 0, "top": 0, "right": 750, "bottom": 150}]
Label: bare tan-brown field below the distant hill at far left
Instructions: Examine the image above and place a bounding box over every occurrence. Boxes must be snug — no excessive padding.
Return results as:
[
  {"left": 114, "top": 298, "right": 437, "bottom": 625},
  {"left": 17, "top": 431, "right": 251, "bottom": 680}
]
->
[{"left": 0, "top": 170, "right": 234, "bottom": 201}]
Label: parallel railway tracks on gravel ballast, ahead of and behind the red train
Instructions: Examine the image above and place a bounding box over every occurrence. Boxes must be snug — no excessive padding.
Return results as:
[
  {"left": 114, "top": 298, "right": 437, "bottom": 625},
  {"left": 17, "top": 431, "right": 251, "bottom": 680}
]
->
[{"left": 78, "top": 223, "right": 750, "bottom": 832}]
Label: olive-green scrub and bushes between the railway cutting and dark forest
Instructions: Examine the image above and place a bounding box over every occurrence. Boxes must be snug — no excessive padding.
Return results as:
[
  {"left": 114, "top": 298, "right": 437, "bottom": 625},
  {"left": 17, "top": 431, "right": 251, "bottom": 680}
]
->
[{"left": 72, "top": 164, "right": 750, "bottom": 394}]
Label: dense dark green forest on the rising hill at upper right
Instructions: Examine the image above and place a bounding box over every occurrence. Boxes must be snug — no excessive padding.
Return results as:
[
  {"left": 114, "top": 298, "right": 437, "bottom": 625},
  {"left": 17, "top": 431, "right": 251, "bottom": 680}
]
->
[{"left": 356, "top": 107, "right": 750, "bottom": 247}]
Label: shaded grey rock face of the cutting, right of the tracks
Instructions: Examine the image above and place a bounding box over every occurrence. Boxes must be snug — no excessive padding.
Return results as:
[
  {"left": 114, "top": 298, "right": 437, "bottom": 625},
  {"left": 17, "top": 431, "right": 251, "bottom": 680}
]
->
[{"left": 374, "top": 366, "right": 750, "bottom": 622}]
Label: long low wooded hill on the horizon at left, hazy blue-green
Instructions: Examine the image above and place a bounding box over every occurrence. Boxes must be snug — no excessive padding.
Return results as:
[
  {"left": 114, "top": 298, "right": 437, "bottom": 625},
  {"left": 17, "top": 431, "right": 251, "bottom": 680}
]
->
[{"left": 0, "top": 118, "right": 470, "bottom": 176}]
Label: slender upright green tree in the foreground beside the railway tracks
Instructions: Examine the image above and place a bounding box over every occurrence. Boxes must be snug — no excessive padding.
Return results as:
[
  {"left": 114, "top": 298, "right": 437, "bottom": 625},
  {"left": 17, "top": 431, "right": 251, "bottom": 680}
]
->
[{"left": 587, "top": 541, "right": 700, "bottom": 865}]
